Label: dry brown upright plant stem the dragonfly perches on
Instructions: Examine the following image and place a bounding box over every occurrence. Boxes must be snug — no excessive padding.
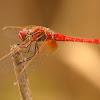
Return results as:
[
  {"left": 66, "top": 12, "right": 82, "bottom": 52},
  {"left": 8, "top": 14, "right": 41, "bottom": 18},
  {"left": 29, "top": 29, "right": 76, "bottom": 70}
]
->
[{"left": 11, "top": 45, "right": 32, "bottom": 100}]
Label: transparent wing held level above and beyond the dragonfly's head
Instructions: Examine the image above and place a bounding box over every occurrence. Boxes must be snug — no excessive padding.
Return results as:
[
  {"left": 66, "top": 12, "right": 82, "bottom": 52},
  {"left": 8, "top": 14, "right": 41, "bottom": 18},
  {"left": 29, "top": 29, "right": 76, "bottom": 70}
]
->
[{"left": 0, "top": 25, "right": 38, "bottom": 40}]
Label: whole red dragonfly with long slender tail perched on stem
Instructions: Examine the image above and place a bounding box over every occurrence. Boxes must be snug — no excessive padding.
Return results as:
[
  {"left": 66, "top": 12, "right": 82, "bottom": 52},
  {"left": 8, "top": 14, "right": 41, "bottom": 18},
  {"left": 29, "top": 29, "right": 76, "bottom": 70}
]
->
[{"left": 0, "top": 25, "right": 100, "bottom": 74}]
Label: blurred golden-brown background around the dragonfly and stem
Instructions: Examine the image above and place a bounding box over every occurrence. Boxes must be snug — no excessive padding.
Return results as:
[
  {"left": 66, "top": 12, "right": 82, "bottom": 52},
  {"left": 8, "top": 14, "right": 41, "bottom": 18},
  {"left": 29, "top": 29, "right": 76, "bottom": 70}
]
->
[{"left": 0, "top": 0, "right": 100, "bottom": 100}]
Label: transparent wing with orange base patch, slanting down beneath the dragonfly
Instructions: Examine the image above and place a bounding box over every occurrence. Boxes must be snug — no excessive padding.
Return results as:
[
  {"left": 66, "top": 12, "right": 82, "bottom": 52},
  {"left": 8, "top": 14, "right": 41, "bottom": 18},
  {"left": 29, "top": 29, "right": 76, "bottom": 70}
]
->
[{"left": 19, "top": 40, "right": 58, "bottom": 74}]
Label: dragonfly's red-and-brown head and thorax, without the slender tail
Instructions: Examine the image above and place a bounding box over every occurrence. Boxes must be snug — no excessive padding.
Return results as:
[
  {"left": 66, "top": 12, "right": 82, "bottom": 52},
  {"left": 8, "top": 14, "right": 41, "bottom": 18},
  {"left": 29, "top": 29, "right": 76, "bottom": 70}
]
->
[{"left": 19, "top": 27, "right": 53, "bottom": 41}]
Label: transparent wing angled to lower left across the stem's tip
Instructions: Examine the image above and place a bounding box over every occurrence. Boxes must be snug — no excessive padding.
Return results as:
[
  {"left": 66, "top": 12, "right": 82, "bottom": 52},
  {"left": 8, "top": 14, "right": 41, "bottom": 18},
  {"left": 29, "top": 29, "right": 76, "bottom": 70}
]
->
[{"left": 0, "top": 41, "right": 31, "bottom": 74}]
